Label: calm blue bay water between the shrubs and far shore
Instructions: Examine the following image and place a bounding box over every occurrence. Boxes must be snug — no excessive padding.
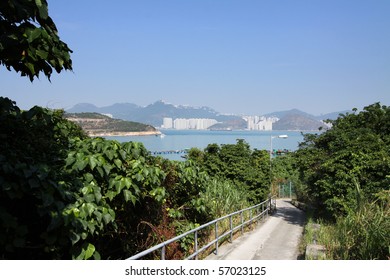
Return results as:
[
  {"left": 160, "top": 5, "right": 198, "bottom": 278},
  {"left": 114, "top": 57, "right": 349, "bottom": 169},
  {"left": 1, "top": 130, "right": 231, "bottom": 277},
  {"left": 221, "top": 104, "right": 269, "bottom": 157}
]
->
[{"left": 106, "top": 130, "right": 312, "bottom": 160}]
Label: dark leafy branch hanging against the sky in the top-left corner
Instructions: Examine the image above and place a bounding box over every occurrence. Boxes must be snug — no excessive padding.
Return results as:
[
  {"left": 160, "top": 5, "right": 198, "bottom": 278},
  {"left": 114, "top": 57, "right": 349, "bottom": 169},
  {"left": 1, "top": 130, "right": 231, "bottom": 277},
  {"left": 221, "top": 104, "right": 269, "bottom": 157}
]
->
[{"left": 0, "top": 0, "right": 72, "bottom": 81}]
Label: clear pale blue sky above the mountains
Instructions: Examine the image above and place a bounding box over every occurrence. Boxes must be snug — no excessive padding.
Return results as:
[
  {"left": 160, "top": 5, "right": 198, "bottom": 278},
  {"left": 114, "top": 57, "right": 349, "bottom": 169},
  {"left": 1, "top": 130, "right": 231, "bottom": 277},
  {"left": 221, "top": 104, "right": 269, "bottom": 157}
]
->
[{"left": 0, "top": 0, "right": 390, "bottom": 115}]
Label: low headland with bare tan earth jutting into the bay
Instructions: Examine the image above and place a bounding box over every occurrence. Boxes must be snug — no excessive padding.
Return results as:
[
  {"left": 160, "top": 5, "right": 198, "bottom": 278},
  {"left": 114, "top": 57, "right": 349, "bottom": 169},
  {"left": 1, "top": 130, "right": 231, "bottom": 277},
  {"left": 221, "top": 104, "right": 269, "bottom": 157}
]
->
[{"left": 65, "top": 113, "right": 161, "bottom": 137}]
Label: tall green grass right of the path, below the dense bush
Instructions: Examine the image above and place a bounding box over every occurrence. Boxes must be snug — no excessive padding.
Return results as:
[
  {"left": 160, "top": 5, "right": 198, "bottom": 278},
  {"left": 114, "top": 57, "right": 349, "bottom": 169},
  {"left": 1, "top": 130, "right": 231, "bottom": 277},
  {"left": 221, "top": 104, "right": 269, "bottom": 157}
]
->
[{"left": 307, "top": 187, "right": 390, "bottom": 260}]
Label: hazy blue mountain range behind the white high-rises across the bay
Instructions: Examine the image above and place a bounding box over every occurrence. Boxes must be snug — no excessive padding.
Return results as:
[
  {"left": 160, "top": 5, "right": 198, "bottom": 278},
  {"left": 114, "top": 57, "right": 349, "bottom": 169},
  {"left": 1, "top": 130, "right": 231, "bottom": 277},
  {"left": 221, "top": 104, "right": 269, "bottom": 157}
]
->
[{"left": 67, "top": 100, "right": 349, "bottom": 131}]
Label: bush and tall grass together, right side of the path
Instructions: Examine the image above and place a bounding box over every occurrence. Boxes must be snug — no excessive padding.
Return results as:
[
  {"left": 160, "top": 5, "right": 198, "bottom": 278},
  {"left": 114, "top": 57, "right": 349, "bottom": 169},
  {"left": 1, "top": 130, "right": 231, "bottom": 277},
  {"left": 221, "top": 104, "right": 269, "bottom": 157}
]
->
[{"left": 284, "top": 103, "right": 390, "bottom": 259}]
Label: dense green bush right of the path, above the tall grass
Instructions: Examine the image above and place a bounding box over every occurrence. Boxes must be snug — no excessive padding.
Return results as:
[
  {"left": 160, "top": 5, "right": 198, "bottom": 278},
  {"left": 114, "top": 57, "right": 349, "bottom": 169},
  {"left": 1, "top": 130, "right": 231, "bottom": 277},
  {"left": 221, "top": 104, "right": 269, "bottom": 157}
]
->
[{"left": 296, "top": 103, "right": 390, "bottom": 217}]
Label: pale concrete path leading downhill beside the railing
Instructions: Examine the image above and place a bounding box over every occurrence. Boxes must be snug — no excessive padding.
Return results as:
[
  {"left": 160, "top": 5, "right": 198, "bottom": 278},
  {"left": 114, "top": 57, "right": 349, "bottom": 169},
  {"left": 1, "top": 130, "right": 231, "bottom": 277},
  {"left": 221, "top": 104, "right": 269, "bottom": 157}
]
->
[{"left": 206, "top": 200, "right": 305, "bottom": 260}]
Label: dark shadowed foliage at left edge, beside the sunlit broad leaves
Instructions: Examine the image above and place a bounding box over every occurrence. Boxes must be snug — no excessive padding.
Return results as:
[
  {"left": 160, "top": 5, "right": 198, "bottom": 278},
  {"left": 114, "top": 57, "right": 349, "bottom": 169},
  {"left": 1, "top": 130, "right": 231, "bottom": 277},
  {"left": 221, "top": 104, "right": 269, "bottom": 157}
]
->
[{"left": 0, "top": 97, "right": 85, "bottom": 259}]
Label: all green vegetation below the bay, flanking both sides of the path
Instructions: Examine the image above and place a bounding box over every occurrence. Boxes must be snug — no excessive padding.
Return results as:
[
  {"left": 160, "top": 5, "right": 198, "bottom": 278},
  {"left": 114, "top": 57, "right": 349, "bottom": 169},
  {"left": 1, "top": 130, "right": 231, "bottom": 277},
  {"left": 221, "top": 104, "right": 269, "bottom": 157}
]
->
[{"left": 0, "top": 98, "right": 390, "bottom": 259}]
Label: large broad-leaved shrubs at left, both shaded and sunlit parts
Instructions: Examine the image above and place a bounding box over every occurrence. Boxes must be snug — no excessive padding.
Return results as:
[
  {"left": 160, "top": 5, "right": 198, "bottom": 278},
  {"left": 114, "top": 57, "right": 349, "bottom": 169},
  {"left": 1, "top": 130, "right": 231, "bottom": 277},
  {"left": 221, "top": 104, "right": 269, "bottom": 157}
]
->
[{"left": 0, "top": 98, "right": 169, "bottom": 259}]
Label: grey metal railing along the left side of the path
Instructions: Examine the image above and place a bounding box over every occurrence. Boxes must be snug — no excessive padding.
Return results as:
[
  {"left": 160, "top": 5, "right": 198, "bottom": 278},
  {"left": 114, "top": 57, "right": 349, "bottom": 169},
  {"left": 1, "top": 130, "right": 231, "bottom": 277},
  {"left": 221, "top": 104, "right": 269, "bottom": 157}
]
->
[{"left": 128, "top": 197, "right": 276, "bottom": 260}]
